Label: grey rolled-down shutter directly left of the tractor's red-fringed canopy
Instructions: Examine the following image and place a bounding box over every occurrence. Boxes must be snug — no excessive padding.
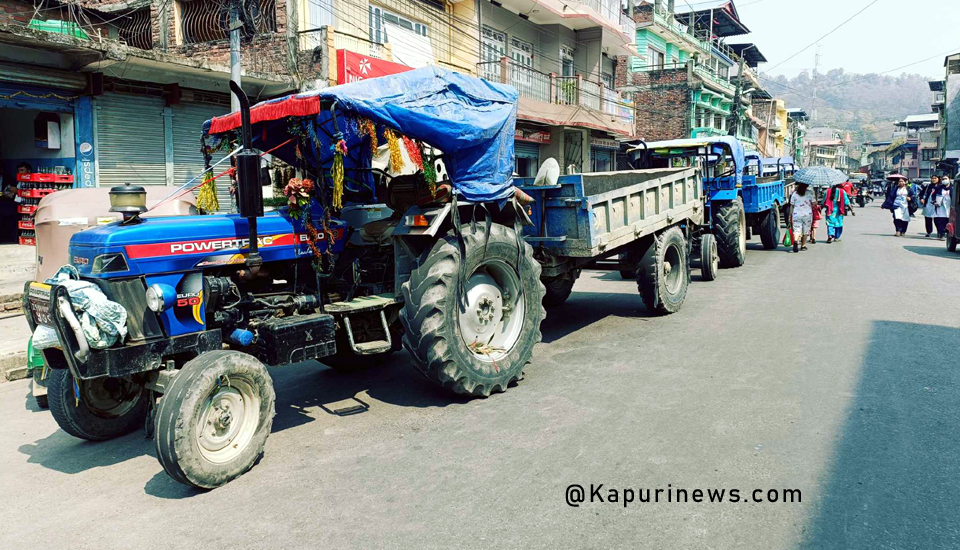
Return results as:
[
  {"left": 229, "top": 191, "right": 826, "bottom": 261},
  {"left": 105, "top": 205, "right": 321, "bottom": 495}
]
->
[{"left": 170, "top": 103, "right": 230, "bottom": 212}]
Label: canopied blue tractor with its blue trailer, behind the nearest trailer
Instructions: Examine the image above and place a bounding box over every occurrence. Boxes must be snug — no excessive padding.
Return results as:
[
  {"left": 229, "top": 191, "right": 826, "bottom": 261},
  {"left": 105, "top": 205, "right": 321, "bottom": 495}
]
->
[{"left": 633, "top": 136, "right": 785, "bottom": 268}]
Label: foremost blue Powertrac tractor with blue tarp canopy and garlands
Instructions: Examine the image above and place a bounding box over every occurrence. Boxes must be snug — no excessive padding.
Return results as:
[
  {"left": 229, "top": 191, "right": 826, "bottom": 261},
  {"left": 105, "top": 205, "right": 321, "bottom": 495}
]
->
[{"left": 24, "top": 68, "right": 544, "bottom": 488}]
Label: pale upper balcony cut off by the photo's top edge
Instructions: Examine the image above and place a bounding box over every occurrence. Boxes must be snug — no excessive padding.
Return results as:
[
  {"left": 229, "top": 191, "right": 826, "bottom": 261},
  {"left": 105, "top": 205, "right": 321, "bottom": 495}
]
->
[{"left": 499, "top": 0, "right": 640, "bottom": 56}]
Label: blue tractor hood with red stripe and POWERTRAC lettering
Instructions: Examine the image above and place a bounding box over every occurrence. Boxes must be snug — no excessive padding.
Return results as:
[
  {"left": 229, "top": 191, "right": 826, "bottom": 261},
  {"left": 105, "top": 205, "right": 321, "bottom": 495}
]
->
[{"left": 70, "top": 212, "right": 346, "bottom": 278}]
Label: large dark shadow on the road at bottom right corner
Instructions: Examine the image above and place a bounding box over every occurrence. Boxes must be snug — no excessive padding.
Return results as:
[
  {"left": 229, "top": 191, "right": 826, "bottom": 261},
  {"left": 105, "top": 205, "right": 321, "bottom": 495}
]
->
[{"left": 802, "top": 321, "right": 960, "bottom": 550}]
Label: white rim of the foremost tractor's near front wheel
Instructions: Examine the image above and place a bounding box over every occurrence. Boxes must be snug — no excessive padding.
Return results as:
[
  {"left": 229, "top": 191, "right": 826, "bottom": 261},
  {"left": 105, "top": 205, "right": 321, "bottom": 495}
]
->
[{"left": 197, "top": 377, "right": 260, "bottom": 464}]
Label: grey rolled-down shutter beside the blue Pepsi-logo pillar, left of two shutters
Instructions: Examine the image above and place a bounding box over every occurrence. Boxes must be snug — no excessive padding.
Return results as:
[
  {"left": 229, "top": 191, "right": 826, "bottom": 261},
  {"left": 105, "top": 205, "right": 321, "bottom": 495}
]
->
[{"left": 97, "top": 93, "right": 167, "bottom": 187}]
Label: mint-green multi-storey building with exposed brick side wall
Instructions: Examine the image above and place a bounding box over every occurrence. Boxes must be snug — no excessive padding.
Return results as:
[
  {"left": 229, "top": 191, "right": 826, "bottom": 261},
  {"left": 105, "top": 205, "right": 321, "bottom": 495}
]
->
[{"left": 618, "top": 0, "right": 773, "bottom": 149}]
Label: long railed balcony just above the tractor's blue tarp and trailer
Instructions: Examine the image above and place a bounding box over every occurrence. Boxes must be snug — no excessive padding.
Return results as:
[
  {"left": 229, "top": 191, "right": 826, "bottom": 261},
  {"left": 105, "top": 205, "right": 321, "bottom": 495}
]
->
[{"left": 477, "top": 57, "right": 634, "bottom": 136}]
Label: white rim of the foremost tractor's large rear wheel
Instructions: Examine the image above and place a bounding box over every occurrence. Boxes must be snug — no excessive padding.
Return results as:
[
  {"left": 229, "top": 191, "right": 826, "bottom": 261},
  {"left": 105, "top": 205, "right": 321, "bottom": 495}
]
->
[{"left": 457, "top": 260, "right": 524, "bottom": 363}]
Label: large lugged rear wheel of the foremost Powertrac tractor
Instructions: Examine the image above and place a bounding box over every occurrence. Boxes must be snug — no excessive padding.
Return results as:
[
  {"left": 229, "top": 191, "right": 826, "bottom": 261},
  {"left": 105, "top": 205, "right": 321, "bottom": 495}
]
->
[{"left": 400, "top": 223, "right": 546, "bottom": 397}]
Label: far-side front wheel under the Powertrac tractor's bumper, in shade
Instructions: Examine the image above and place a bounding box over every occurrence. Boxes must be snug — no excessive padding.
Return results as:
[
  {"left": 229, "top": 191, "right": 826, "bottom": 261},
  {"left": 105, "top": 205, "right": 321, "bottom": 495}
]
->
[{"left": 47, "top": 369, "right": 150, "bottom": 441}]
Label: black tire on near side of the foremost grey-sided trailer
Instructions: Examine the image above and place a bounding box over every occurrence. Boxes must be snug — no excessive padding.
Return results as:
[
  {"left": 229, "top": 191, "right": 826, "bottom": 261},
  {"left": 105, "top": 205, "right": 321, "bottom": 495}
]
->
[{"left": 637, "top": 227, "right": 690, "bottom": 315}]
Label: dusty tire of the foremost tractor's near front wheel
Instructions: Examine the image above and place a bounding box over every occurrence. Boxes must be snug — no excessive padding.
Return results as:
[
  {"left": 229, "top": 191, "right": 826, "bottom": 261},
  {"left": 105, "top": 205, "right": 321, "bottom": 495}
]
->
[{"left": 154, "top": 350, "right": 276, "bottom": 489}]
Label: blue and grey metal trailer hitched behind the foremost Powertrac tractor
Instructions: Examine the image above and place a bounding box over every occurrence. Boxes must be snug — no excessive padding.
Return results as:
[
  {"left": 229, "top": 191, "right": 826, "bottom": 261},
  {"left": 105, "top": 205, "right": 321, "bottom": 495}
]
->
[{"left": 517, "top": 168, "right": 719, "bottom": 314}]
